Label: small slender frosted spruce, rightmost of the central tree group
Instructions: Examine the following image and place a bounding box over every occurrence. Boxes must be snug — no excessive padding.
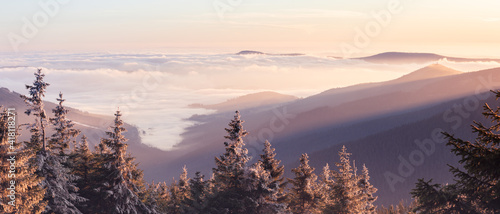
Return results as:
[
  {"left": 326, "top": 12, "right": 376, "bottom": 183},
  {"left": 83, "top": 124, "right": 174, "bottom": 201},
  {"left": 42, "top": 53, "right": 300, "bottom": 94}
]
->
[{"left": 358, "top": 164, "right": 378, "bottom": 214}]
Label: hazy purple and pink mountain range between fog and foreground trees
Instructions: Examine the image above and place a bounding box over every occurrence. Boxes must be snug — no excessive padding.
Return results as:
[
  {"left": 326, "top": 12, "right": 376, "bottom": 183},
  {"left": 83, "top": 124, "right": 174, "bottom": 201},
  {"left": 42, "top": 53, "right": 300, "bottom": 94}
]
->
[{"left": 0, "top": 53, "right": 500, "bottom": 205}]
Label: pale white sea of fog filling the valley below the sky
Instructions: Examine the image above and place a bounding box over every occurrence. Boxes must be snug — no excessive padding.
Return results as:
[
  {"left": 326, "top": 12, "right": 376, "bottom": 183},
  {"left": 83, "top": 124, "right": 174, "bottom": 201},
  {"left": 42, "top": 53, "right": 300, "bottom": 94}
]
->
[{"left": 0, "top": 51, "right": 499, "bottom": 149}]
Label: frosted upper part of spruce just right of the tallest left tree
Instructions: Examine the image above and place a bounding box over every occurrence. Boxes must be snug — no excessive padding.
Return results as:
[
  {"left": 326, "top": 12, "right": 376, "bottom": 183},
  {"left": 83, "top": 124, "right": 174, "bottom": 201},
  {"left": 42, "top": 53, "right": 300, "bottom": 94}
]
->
[{"left": 49, "top": 93, "right": 80, "bottom": 155}]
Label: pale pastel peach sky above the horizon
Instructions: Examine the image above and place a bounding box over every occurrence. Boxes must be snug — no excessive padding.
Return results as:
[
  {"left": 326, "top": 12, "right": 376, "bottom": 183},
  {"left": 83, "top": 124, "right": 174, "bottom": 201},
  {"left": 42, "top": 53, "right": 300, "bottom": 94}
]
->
[{"left": 0, "top": 0, "right": 500, "bottom": 57}]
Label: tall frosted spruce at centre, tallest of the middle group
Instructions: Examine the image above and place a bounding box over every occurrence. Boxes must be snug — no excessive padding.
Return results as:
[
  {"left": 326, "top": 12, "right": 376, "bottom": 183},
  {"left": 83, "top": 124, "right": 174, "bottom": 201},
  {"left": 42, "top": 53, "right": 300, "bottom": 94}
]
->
[{"left": 208, "top": 111, "right": 254, "bottom": 213}]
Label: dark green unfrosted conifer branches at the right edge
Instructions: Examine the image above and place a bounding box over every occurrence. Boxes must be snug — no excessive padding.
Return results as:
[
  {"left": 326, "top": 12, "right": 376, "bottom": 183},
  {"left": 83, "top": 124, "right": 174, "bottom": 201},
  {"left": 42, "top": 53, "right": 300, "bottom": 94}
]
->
[{"left": 412, "top": 91, "right": 500, "bottom": 213}]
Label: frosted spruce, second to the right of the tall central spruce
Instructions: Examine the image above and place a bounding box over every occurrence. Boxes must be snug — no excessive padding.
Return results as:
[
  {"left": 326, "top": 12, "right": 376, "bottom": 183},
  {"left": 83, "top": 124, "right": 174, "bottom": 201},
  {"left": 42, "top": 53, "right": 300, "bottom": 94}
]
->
[{"left": 287, "top": 154, "right": 322, "bottom": 214}]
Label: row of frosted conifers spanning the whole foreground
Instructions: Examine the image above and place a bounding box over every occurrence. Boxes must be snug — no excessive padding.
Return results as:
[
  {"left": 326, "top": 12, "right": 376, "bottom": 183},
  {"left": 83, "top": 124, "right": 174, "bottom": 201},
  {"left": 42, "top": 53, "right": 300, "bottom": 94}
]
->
[{"left": 0, "top": 69, "right": 500, "bottom": 214}]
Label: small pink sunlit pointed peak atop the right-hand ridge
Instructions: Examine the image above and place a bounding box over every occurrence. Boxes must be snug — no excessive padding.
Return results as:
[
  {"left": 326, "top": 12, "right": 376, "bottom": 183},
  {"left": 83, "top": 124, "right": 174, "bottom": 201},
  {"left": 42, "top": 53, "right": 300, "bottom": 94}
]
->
[{"left": 395, "top": 63, "right": 462, "bottom": 83}]
